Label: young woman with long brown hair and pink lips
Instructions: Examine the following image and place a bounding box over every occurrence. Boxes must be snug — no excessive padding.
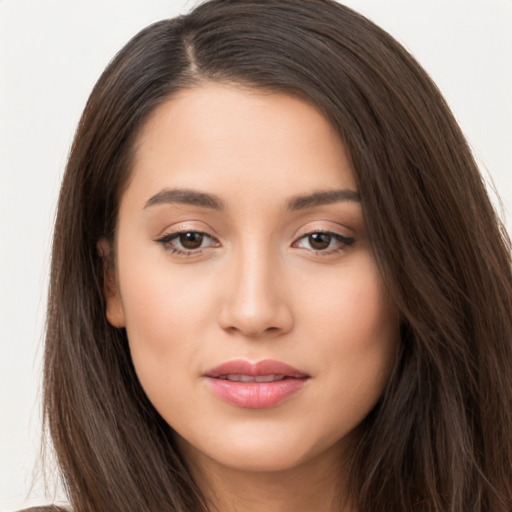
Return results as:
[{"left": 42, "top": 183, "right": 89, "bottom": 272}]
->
[{"left": 29, "top": 0, "right": 512, "bottom": 512}]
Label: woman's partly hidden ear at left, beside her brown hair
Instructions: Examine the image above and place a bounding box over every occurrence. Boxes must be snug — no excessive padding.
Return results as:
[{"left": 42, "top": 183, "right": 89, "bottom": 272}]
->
[{"left": 96, "top": 238, "right": 126, "bottom": 328}]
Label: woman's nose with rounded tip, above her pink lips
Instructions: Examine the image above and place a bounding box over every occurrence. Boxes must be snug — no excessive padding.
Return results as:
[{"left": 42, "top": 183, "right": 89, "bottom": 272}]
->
[{"left": 218, "top": 246, "right": 294, "bottom": 338}]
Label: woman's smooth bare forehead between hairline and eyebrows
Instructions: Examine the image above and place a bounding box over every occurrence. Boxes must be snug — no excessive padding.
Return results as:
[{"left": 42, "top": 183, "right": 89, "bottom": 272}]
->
[{"left": 125, "top": 84, "right": 356, "bottom": 208}]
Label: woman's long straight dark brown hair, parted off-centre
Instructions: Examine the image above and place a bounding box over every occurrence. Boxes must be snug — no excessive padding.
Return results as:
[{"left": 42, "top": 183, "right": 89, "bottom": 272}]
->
[{"left": 44, "top": 0, "right": 512, "bottom": 512}]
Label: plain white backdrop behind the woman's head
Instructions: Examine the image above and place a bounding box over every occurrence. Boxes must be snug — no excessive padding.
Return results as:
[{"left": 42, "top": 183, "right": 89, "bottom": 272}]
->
[{"left": 0, "top": 0, "right": 512, "bottom": 512}]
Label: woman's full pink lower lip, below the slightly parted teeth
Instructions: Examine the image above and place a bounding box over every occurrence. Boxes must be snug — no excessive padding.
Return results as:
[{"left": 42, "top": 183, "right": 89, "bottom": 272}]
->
[{"left": 207, "top": 377, "right": 307, "bottom": 409}]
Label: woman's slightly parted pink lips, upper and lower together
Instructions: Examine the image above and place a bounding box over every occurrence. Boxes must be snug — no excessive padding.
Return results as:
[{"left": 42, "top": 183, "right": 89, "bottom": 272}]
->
[{"left": 205, "top": 359, "right": 310, "bottom": 409}]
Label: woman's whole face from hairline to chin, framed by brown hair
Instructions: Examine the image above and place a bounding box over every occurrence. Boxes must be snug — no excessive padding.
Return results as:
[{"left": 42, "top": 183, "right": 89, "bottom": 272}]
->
[{"left": 106, "top": 84, "right": 398, "bottom": 471}]
